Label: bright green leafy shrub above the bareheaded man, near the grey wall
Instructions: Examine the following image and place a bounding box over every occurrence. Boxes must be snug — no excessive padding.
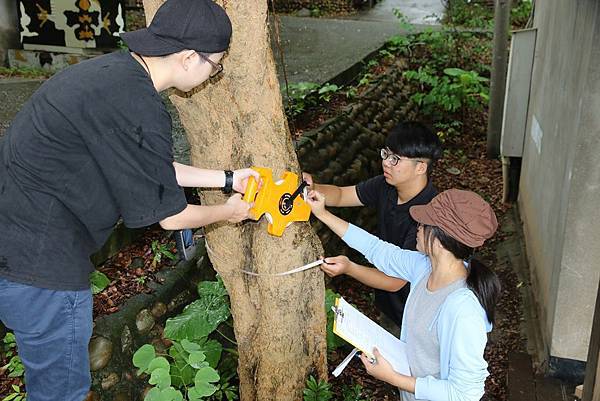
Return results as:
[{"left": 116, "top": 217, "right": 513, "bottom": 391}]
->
[{"left": 404, "top": 67, "right": 489, "bottom": 119}]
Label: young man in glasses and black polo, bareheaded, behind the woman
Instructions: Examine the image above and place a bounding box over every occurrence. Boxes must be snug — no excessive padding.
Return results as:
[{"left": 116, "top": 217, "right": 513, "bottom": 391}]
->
[{"left": 303, "top": 122, "right": 442, "bottom": 327}]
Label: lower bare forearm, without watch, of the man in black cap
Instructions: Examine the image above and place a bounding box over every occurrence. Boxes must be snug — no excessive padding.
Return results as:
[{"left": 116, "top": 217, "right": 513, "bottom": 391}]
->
[{"left": 160, "top": 204, "right": 232, "bottom": 230}]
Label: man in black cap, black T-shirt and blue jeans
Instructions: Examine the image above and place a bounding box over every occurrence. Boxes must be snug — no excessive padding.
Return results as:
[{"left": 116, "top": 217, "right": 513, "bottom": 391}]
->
[{"left": 0, "top": 0, "right": 248, "bottom": 401}]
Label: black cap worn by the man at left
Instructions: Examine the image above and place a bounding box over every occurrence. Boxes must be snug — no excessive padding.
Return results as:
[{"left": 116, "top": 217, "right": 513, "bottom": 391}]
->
[{"left": 121, "top": 0, "right": 231, "bottom": 56}]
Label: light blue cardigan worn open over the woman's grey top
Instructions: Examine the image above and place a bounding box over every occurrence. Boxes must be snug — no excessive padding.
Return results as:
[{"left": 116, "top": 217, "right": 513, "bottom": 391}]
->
[{"left": 342, "top": 224, "right": 492, "bottom": 401}]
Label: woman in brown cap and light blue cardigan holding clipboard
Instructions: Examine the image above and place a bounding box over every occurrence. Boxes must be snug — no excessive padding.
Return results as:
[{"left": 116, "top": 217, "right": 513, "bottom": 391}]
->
[{"left": 307, "top": 189, "right": 500, "bottom": 401}]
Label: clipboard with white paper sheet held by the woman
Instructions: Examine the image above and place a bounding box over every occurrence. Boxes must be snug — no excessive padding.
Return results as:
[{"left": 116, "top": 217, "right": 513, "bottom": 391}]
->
[{"left": 333, "top": 297, "right": 410, "bottom": 376}]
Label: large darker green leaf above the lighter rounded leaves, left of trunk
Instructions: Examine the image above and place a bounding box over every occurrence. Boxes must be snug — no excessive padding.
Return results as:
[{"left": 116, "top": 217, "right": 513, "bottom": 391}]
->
[{"left": 164, "top": 277, "right": 231, "bottom": 341}]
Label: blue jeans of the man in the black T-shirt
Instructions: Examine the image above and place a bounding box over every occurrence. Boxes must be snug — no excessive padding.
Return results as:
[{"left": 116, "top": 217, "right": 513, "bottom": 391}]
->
[{"left": 0, "top": 277, "right": 92, "bottom": 401}]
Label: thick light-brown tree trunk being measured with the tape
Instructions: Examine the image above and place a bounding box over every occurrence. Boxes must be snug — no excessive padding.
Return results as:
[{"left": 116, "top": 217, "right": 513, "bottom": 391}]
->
[{"left": 139, "top": 0, "right": 327, "bottom": 401}]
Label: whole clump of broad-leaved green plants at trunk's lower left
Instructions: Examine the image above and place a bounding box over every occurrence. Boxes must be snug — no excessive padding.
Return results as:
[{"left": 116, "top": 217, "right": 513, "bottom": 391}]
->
[{"left": 133, "top": 278, "right": 238, "bottom": 401}]
